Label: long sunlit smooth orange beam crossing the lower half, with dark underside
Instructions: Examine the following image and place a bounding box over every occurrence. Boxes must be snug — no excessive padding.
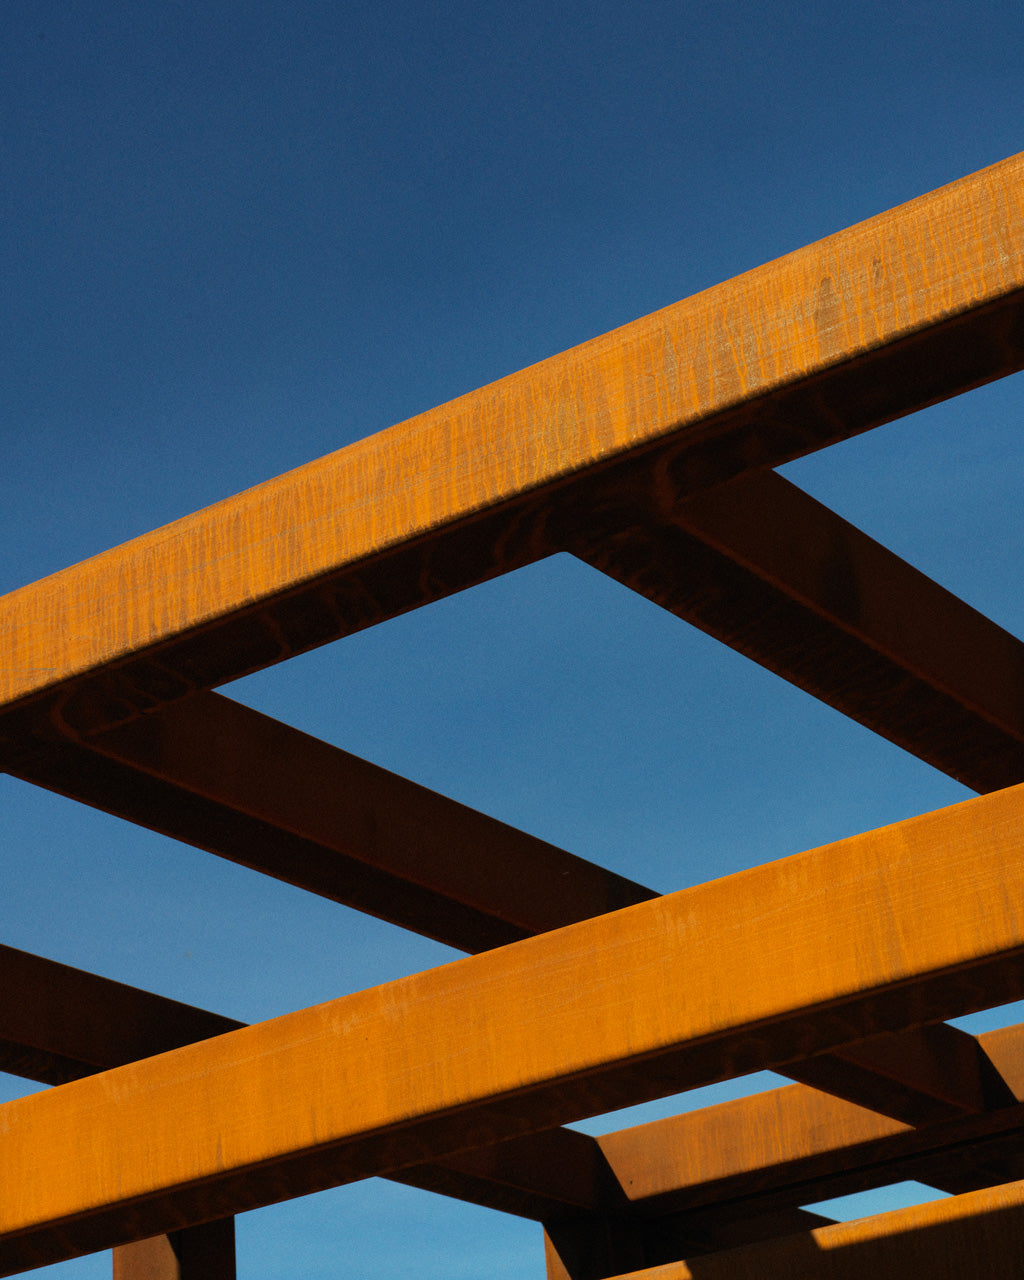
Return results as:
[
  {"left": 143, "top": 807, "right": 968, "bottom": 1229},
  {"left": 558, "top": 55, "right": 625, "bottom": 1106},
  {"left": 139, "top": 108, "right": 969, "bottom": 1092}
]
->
[{"left": 0, "top": 788, "right": 1024, "bottom": 1272}]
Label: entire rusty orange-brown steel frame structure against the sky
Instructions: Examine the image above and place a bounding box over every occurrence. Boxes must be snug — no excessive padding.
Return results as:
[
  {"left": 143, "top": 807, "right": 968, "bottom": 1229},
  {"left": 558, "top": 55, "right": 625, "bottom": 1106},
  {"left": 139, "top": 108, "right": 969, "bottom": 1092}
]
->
[{"left": 0, "top": 156, "right": 1024, "bottom": 1280}]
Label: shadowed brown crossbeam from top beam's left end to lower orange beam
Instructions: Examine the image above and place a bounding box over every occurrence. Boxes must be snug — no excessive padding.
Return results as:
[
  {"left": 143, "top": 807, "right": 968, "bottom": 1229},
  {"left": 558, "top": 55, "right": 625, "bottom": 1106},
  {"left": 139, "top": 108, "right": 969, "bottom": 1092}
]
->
[{"left": 4, "top": 694, "right": 655, "bottom": 951}]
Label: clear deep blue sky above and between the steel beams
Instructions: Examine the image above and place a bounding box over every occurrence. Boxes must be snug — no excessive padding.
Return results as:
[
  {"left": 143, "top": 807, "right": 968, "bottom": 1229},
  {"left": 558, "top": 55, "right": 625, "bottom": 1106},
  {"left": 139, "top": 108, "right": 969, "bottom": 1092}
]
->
[{"left": 0, "top": 0, "right": 1024, "bottom": 1280}]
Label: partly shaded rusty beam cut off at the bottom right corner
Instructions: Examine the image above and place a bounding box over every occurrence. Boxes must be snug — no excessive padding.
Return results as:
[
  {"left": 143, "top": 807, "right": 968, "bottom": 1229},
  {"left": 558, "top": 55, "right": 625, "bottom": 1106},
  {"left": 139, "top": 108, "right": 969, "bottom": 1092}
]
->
[{"left": 576, "top": 1181, "right": 1024, "bottom": 1280}]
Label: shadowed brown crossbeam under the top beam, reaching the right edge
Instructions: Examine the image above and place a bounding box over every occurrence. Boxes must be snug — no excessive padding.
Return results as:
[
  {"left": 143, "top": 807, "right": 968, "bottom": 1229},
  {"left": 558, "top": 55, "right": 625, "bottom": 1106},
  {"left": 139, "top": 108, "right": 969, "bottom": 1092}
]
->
[{"left": 570, "top": 471, "right": 1024, "bottom": 791}]
